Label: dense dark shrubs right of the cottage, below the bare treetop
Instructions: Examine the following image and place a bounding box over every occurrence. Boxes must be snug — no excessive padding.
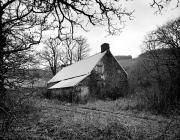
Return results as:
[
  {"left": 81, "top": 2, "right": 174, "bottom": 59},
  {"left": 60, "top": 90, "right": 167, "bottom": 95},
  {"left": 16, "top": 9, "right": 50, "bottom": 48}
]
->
[{"left": 129, "top": 53, "right": 179, "bottom": 113}]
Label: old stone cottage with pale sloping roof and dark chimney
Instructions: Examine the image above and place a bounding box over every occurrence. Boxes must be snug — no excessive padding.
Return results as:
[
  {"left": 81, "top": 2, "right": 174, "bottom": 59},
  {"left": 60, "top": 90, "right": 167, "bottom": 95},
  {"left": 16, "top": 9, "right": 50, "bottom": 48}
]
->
[{"left": 47, "top": 43, "right": 128, "bottom": 99}]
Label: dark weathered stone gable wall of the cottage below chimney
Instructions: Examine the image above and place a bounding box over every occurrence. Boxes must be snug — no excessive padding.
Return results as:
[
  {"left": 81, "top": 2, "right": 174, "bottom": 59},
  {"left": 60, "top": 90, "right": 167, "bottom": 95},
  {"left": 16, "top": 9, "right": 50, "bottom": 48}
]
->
[{"left": 94, "top": 51, "right": 128, "bottom": 96}]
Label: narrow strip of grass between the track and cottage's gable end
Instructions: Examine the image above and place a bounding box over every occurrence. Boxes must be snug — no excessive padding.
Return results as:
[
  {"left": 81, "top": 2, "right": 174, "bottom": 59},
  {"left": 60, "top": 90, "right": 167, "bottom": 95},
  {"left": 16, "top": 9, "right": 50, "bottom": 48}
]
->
[{"left": 78, "top": 98, "right": 163, "bottom": 120}]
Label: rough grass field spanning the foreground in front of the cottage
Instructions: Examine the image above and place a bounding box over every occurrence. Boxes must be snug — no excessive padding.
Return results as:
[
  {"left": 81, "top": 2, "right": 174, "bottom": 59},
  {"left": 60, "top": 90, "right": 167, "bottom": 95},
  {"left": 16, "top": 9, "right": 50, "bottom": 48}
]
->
[{"left": 2, "top": 91, "right": 180, "bottom": 140}]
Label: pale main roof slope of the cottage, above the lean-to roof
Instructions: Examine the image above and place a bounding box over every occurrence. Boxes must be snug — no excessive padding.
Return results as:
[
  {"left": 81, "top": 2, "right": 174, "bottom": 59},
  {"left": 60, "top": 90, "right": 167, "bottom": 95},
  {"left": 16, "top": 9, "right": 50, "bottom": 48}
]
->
[{"left": 48, "top": 51, "right": 106, "bottom": 84}]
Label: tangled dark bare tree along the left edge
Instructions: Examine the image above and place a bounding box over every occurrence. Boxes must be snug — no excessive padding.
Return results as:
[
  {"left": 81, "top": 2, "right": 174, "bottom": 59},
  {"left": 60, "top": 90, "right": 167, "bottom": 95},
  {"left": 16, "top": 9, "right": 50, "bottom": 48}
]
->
[{"left": 0, "top": 0, "right": 43, "bottom": 98}]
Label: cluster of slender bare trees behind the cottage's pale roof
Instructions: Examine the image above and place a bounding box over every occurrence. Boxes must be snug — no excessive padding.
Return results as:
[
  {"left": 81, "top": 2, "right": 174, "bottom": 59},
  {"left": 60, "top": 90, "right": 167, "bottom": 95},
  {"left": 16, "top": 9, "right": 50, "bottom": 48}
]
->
[{"left": 37, "top": 36, "right": 90, "bottom": 75}]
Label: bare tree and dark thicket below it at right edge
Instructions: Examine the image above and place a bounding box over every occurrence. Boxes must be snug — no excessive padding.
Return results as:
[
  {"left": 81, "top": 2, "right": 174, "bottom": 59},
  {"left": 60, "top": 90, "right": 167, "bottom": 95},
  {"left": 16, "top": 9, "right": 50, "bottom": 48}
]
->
[{"left": 129, "top": 18, "right": 180, "bottom": 110}]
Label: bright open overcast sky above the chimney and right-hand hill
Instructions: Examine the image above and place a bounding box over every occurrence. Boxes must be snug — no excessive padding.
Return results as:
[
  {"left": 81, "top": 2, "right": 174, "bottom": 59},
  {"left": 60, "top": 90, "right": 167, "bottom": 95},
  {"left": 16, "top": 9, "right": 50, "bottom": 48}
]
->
[{"left": 82, "top": 0, "right": 180, "bottom": 57}]
